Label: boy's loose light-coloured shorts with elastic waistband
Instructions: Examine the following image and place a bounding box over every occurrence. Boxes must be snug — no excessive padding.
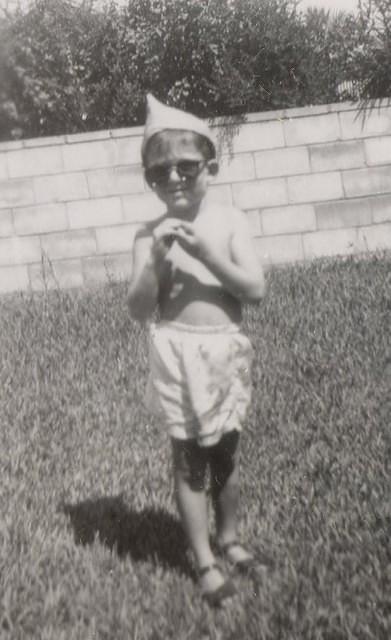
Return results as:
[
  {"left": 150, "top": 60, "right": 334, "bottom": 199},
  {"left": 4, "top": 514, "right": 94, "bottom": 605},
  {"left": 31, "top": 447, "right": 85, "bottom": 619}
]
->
[{"left": 146, "top": 322, "right": 253, "bottom": 446}]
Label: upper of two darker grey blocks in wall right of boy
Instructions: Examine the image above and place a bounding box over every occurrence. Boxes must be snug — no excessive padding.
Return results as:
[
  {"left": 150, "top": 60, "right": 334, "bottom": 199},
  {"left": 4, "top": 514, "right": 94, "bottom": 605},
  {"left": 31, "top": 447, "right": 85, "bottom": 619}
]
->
[{"left": 309, "top": 140, "right": 365, "bottom": 171}]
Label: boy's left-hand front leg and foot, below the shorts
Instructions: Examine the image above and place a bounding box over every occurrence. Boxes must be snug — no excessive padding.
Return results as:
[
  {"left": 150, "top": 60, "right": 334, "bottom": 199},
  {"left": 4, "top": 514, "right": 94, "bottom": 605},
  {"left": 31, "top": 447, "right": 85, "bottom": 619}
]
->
[{"left": 172, "top": 438, "right": 230, "bottom": 591}]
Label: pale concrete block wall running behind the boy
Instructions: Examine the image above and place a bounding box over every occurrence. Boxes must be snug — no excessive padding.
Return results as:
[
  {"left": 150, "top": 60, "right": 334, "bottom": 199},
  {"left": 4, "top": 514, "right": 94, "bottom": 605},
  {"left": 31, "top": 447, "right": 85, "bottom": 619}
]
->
[{"left": 0, "top": 101, "right": 391, "bottom": 292}]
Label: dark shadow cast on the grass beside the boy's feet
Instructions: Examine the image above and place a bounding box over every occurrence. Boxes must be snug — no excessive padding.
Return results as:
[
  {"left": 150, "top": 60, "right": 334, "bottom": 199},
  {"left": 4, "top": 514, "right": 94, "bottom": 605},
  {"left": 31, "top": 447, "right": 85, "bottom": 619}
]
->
[{"left": 60, "top": 495, "right": 193, "bottom": 576}]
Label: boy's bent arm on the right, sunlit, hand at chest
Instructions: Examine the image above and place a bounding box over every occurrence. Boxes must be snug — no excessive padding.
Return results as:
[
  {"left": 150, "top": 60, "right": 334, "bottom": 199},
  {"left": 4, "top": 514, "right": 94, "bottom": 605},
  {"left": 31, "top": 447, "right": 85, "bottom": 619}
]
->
[{"left": 177, "top": 210, "right": 265, "bottom": 302}]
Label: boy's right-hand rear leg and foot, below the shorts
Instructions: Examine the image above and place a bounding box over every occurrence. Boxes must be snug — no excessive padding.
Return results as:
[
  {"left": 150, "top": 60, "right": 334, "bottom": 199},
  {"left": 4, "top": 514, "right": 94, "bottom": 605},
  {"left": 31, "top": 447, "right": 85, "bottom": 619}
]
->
[{"left": 209, "top": 431, "right": 252, "bottom": 563}]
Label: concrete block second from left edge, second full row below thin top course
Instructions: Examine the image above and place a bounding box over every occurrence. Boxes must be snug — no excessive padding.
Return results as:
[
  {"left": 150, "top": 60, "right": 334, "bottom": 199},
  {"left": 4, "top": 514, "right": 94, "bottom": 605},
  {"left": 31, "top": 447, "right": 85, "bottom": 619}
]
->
[{"left": 34, "top": 173, "right": 89, "bottom": 203}]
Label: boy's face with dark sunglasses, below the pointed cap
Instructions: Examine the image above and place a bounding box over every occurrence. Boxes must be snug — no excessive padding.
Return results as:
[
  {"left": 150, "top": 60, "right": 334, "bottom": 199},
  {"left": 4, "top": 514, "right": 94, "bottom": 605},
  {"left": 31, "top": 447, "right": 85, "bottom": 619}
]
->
[{"left": 144, "top": 131, "right": 217, "bottom": 217}]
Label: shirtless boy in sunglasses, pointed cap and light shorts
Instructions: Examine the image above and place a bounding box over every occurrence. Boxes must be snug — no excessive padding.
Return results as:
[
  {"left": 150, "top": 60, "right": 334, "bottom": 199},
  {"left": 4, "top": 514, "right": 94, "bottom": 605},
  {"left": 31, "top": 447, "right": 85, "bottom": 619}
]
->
[{"left": 129, "top": 95, "right": 265, "bottom": 605}]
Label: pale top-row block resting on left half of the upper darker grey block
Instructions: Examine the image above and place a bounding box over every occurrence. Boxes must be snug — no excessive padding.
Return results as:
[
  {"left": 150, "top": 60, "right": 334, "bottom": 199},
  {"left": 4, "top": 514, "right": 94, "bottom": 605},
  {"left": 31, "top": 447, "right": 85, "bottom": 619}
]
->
[{"left": 284, "top": 113, "right": 340, "bottom": 147}]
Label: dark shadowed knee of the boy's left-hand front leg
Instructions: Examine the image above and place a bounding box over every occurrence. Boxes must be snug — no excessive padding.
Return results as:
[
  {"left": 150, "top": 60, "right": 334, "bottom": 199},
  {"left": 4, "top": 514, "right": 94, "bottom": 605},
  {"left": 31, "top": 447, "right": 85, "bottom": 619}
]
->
[{"left": 172, "top": 438, "right": 207, "bottom": 491}]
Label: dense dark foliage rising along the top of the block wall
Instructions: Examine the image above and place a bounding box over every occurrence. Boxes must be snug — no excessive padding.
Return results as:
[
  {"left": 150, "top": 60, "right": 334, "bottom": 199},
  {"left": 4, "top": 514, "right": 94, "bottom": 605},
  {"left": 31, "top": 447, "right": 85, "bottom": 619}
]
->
[{"left": 0, "top": 0, "right": 391, "bottom": 140}]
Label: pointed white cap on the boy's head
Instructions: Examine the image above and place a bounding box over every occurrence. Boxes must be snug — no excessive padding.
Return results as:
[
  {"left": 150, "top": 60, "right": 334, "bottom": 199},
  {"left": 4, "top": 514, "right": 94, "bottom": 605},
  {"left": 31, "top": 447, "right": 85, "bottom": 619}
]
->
[{"left": 141, "top": 93, "right": 216, "bottom": 158}]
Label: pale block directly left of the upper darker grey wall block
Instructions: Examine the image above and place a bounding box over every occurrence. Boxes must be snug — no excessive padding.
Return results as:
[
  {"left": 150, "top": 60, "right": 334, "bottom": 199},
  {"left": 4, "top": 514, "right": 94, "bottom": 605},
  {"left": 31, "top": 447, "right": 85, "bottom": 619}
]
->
[{"left": 254, "top": 147, "right": 310, "bottom": 178}]
